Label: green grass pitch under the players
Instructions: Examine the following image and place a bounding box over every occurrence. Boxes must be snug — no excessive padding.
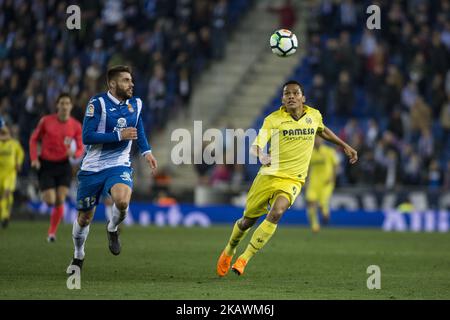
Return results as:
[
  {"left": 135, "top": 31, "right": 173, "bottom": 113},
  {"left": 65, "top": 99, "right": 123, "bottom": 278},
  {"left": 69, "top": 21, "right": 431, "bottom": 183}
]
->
[{"left": 0, "top": 221, "right": 450, "bottom": 300}]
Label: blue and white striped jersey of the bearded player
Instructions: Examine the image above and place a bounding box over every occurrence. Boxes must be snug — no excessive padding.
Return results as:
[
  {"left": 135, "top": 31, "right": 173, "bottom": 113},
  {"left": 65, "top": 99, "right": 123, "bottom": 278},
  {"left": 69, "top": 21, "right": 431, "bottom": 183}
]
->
[{"left": 81, "top": 92, "right": 151, "bottom": 172}]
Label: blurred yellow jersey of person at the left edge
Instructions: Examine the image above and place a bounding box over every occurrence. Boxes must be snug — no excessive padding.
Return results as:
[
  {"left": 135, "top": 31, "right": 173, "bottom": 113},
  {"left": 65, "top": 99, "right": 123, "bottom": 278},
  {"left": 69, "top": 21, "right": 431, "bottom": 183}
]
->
[{"left": 0, "top": 139, "right": 24, "bottom": 177}]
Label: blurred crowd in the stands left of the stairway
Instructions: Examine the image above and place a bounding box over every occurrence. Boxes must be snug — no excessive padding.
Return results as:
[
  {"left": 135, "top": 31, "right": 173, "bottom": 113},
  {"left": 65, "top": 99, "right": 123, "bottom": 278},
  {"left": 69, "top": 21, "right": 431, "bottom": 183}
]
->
[{"left": 0, "top": 0, "right": 249, "bottom": 178}]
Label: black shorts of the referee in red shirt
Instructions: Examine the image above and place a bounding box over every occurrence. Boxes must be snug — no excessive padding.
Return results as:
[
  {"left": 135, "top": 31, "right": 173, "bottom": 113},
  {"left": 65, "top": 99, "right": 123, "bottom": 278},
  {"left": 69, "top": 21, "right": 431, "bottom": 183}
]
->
[{"left": 38, "top": 159, "right": 72, "bottom": 191}]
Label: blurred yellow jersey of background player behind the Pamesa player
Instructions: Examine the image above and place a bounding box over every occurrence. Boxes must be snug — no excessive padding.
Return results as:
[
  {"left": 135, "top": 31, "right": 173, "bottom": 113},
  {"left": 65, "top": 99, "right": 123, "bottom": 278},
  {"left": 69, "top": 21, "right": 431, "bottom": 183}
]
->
[{"left": 309, "top": 144, "right": 339, "bottom": 187}]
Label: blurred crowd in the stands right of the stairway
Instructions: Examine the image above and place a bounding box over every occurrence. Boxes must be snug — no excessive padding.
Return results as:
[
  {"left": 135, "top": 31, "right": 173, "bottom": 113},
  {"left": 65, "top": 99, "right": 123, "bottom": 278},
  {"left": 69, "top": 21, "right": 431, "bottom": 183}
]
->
[{"left": 305, "top": 0, "right": 450, "bottom": 190}]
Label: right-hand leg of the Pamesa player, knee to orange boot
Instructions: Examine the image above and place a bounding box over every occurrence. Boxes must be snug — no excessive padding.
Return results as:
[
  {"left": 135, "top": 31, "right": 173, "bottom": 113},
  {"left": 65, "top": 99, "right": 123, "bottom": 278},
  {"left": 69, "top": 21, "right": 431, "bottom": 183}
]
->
[{"left": 231, "top": 192, "right": 291, "bottom": 275}]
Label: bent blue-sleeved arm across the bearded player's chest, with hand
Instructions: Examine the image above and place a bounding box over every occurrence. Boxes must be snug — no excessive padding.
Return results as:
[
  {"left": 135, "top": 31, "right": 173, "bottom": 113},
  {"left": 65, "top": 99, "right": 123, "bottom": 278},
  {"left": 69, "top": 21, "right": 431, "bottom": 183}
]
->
[{"left": 82, "top": 99, "right": 137, "bottom": 145}]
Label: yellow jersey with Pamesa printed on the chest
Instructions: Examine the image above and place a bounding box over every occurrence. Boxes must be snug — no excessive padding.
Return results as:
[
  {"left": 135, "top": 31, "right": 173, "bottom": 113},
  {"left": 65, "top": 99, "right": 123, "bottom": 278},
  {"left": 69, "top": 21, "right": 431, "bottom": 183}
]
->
[{"left": 253, "top": 105, "right": 325, "bottom": 183}]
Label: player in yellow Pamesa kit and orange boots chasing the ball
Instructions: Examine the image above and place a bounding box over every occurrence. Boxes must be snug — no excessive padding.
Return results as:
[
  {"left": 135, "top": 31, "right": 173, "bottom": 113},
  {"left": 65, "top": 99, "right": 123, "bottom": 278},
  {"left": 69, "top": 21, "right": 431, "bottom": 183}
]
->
[{"left": 216, "top": 80, "right": 358, "bottom": 277}]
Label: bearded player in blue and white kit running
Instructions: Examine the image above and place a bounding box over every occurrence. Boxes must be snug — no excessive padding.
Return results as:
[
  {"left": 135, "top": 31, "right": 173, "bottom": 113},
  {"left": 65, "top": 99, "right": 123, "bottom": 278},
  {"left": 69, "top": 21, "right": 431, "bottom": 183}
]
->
[{"left": 67, "top": 66, "right": 157, "bottom": 269}]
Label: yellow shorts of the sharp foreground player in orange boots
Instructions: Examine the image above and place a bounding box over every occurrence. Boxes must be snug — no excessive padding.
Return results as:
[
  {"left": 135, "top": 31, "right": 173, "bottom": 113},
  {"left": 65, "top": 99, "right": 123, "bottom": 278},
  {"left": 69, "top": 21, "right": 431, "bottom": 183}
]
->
[{"left": 244, "top": 174, "right": 303, "bottom": 218}]
